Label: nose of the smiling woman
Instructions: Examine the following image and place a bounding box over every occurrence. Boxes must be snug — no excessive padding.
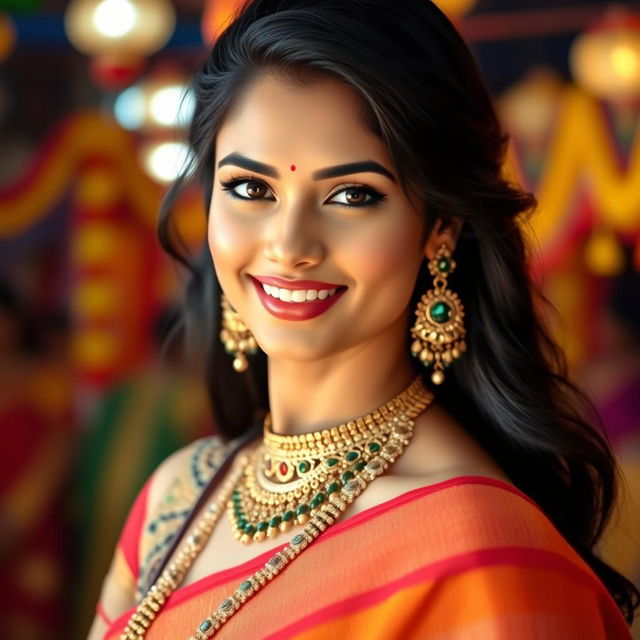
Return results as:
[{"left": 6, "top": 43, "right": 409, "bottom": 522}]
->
[{"left": 264, "top": 206, "right": 325, "bottom": 269}]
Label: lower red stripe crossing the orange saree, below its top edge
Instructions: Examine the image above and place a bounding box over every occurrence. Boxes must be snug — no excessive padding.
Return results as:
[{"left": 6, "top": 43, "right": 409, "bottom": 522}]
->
[{"left": 263, "top": 547, "right": 611, "bottom": 640}]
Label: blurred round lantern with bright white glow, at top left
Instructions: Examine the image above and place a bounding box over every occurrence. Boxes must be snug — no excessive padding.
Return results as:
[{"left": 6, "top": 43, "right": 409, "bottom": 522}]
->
[{"left": 65, "top": 0, "right": 176, "bottom": 58}]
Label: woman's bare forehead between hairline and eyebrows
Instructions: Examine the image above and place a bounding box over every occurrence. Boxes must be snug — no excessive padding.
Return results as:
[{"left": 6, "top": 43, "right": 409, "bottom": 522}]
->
[{"left": 216, "top": 73, "right": 388, "bottom": 164}]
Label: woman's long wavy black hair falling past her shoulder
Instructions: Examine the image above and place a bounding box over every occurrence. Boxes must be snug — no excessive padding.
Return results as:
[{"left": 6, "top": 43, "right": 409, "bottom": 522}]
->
[{"left": 159, "top": 0, "right": 640, "bottom": 622}]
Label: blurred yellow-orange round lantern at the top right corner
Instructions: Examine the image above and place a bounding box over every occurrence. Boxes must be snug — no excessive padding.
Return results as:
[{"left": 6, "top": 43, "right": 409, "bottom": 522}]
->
[{"left": 569, "top": 6, "right": 640, "bottom": 101}]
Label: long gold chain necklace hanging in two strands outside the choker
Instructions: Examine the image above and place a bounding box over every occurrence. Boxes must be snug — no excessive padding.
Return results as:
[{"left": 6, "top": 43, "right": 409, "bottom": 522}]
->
[{"left": 120, "top": 379, "right": 433, "bottom": 640}]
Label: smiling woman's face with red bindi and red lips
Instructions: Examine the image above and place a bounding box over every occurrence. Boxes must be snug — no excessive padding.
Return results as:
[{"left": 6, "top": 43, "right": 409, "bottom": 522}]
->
[{"left": 208, "top": 75, "right": 424, "bottom": 361}]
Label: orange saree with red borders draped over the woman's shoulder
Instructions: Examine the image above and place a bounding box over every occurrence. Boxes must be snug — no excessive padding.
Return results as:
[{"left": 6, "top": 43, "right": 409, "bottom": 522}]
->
[{"left": 100, "top": 476, "right": 631, "bottom": 640}]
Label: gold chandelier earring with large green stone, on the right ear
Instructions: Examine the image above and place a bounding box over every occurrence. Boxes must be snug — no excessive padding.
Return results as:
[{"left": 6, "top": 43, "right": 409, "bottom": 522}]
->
[{"left": 411, "top": 244, "right": 467, "bottom": 384}]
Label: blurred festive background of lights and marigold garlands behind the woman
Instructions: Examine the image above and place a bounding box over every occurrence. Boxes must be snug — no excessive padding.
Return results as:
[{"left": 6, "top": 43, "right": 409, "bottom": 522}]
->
[{"left": 0, "top": 0, "right": 640, "bottom": 640}]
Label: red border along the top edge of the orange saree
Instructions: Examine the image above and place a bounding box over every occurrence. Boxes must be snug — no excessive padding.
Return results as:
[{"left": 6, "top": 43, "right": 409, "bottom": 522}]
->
[{"left": 105, "top": 475, "right": 546, "bottom": 637}]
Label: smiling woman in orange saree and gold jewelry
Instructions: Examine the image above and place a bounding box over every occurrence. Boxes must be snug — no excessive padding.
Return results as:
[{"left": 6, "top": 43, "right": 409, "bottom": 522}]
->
[{"left": 91, "top": 0, "right": 638, "bottom": 639}]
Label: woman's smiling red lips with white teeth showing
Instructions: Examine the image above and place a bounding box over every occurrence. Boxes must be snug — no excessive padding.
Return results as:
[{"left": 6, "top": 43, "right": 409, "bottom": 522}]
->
[{"left": 251, "top": 276, "right": 347, "bottom": 320}]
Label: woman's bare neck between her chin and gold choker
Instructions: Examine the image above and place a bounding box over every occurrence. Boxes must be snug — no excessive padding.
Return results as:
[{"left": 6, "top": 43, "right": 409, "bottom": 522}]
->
[{"left": 269, "top": 316, "right": 415, "bottom": 435}]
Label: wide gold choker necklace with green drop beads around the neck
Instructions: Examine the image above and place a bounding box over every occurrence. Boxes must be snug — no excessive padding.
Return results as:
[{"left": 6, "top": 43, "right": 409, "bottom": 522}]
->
[{"left": 227, "top": 376, "right": 432, "bottom": 544}]
